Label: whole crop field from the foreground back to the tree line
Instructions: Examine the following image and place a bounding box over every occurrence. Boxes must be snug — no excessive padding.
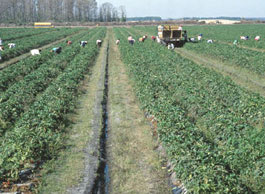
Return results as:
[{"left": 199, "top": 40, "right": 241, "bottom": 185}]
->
[{"left": 0, "top": 25, "right": 265, "bottom": 193}]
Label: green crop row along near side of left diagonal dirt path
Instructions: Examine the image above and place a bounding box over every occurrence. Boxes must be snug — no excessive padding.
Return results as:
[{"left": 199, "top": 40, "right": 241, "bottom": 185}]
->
[{"left": 0, "top": 29, "right": 98, "bottom": 93}]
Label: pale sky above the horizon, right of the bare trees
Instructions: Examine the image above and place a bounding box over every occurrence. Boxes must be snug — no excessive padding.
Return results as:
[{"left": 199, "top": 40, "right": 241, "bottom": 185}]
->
[{"left": 97, "top": 0, "right": 265, "bottom": 19}]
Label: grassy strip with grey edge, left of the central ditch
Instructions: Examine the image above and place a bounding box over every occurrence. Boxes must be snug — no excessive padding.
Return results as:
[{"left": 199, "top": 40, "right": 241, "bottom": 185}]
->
[{"left": 39, "top": 32, "right": 108, "bottom": 194}]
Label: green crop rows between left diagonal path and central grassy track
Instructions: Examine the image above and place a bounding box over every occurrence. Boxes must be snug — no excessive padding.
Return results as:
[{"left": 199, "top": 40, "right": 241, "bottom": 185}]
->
[{"left": 0, "top": 28, "right": 106, "bottom": 191}]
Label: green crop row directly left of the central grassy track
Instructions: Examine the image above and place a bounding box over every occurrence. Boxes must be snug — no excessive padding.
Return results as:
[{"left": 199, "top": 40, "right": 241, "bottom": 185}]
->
[{"left": 0, "top": 26, "right": 105, "bottom": 182}]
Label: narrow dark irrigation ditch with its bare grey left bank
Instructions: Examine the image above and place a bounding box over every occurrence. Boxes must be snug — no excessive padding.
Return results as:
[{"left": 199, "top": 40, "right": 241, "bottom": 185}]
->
[{"left": 67, "top": 38, "right": 110, "bottom": 194}]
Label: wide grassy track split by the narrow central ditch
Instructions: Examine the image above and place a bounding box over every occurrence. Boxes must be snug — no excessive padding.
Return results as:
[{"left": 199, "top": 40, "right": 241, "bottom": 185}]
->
[{"left": 39, "top": 28, "right": 171, "bottom": 194}]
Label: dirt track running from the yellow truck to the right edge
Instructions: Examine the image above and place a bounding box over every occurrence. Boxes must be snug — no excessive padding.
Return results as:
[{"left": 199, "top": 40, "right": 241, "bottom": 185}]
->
[{"left": 175, "top": 48, "right": 265, "bottom": 96}]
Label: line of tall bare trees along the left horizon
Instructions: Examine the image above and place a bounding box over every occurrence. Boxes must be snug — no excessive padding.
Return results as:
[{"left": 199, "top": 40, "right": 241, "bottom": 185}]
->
[{"left": 0, "top": 0, "right": 126, "bottom": 24}]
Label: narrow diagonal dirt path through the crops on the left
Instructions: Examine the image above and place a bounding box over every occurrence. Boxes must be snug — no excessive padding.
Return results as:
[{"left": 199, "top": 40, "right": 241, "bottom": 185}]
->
[{"left": 0, "top": 31, "right": 80, "bottom": 70}]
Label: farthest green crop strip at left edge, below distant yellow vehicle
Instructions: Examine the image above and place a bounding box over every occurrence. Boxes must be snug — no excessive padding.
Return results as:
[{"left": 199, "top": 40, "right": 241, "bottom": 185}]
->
[{"left": 0, "top": 28, "right": 58, "bottom": 41}]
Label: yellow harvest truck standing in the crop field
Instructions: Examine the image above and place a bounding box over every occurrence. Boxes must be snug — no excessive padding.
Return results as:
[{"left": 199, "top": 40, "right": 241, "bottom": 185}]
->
[{"left": 158, "top": 25, "right": 186, "bottom": 47}]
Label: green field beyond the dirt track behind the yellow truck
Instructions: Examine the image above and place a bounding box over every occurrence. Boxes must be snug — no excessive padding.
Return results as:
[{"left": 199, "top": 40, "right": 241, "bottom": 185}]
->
[{"left": 135, "top": 25, "right": 265, "bottom": 77}]
